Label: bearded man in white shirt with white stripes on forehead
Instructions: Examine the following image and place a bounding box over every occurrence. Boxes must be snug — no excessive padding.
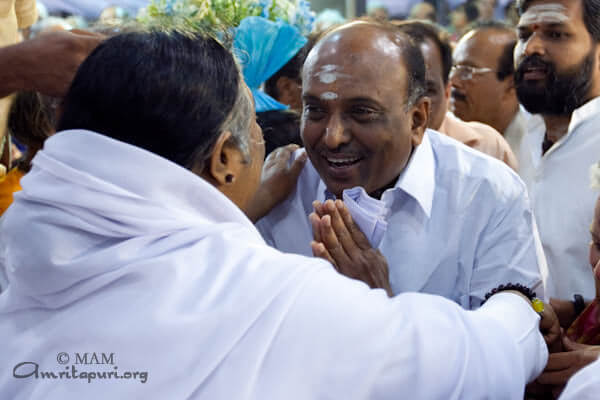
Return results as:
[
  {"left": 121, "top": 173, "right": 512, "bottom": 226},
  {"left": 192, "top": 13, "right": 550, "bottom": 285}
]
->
[{"left": 514, "top": 0, "right": 600, "bottom": 307}]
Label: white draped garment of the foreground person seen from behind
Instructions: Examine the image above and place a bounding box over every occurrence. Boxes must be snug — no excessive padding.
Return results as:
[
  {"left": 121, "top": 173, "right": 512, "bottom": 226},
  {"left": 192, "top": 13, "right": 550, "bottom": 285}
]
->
[{"left": 0, "top": 131, "right": 547, "bottom": 400}]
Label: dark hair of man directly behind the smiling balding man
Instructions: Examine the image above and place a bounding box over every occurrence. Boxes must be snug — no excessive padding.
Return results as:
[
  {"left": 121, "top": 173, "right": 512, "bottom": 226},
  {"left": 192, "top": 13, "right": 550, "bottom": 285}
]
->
[{"left": 395, "top": 20, "right": 452, "bottom": 84}]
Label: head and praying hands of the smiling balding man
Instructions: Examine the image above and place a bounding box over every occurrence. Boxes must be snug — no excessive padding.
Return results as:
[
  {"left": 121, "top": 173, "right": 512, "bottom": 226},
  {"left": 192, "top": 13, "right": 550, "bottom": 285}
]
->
[{"left": 302, "top": 22, "right": 430, "bottom": 288}]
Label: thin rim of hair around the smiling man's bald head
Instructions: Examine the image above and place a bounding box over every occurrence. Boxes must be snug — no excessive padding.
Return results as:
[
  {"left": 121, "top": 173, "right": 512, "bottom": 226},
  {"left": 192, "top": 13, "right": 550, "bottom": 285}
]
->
[{"left": 315, "top": 17, "right": 427, "bottom": 106}]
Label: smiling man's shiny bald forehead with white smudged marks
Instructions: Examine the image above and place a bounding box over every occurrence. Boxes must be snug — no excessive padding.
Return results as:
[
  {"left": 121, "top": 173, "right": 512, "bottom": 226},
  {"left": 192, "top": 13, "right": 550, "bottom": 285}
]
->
[{"left": 303, "top": 26, "right": 407, "bottom": 96}]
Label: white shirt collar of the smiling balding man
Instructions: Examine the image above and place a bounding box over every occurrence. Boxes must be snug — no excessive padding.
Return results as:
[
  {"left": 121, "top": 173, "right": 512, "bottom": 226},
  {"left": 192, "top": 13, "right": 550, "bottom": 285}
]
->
[{"left": 317, "top": 129, "right": 435, "bottom": 218}]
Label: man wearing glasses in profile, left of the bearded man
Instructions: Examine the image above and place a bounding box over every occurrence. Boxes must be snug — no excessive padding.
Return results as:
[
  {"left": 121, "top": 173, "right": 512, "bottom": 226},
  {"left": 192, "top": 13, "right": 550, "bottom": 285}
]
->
[{"left": 450, "top": 22, "right": 541, "bottom": 157}]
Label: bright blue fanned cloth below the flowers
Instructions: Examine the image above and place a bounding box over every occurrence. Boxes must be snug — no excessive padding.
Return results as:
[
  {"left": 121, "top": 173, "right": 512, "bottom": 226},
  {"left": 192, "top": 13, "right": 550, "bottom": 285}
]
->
[{"left": 233, "top": 17, "right": 307, "bottom": 112}]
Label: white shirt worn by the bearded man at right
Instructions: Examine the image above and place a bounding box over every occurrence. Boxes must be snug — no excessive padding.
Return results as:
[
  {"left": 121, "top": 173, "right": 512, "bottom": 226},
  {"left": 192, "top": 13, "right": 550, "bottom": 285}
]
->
[{"left": 519, "top": 97, "right": 600, "bottom": 300}]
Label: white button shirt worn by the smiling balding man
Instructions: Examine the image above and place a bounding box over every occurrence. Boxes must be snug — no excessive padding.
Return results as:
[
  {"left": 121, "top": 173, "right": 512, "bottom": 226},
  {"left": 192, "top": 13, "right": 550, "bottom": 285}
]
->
[{"left": 257, "top": 130, "right": 544, "bottom": 308}]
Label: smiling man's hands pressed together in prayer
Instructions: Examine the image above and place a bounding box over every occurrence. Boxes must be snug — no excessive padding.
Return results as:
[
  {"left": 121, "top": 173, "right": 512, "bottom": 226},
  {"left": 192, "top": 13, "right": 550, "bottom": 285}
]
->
[{"left": 309, "top": 200, "right": 392, "bottom": 297}]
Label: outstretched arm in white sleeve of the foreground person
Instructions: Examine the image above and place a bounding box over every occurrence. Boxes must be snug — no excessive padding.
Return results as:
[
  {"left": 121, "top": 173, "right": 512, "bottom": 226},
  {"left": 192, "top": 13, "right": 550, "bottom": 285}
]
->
[{"left": 263, "top": 269, "right": 547, "bottom": 400}]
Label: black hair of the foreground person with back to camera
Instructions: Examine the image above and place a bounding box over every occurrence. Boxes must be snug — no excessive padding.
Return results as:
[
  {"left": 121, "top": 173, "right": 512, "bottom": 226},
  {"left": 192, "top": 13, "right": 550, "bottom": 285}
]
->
[{"left": 58, "top": 31, "right": 244, "bottom": 168}]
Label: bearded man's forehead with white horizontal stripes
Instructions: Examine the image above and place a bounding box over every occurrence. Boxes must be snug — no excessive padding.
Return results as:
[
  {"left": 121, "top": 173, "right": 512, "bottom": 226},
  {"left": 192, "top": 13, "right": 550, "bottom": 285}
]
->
[{"left": 517, "top": 0, "right": 583, "bottom": 28}]
